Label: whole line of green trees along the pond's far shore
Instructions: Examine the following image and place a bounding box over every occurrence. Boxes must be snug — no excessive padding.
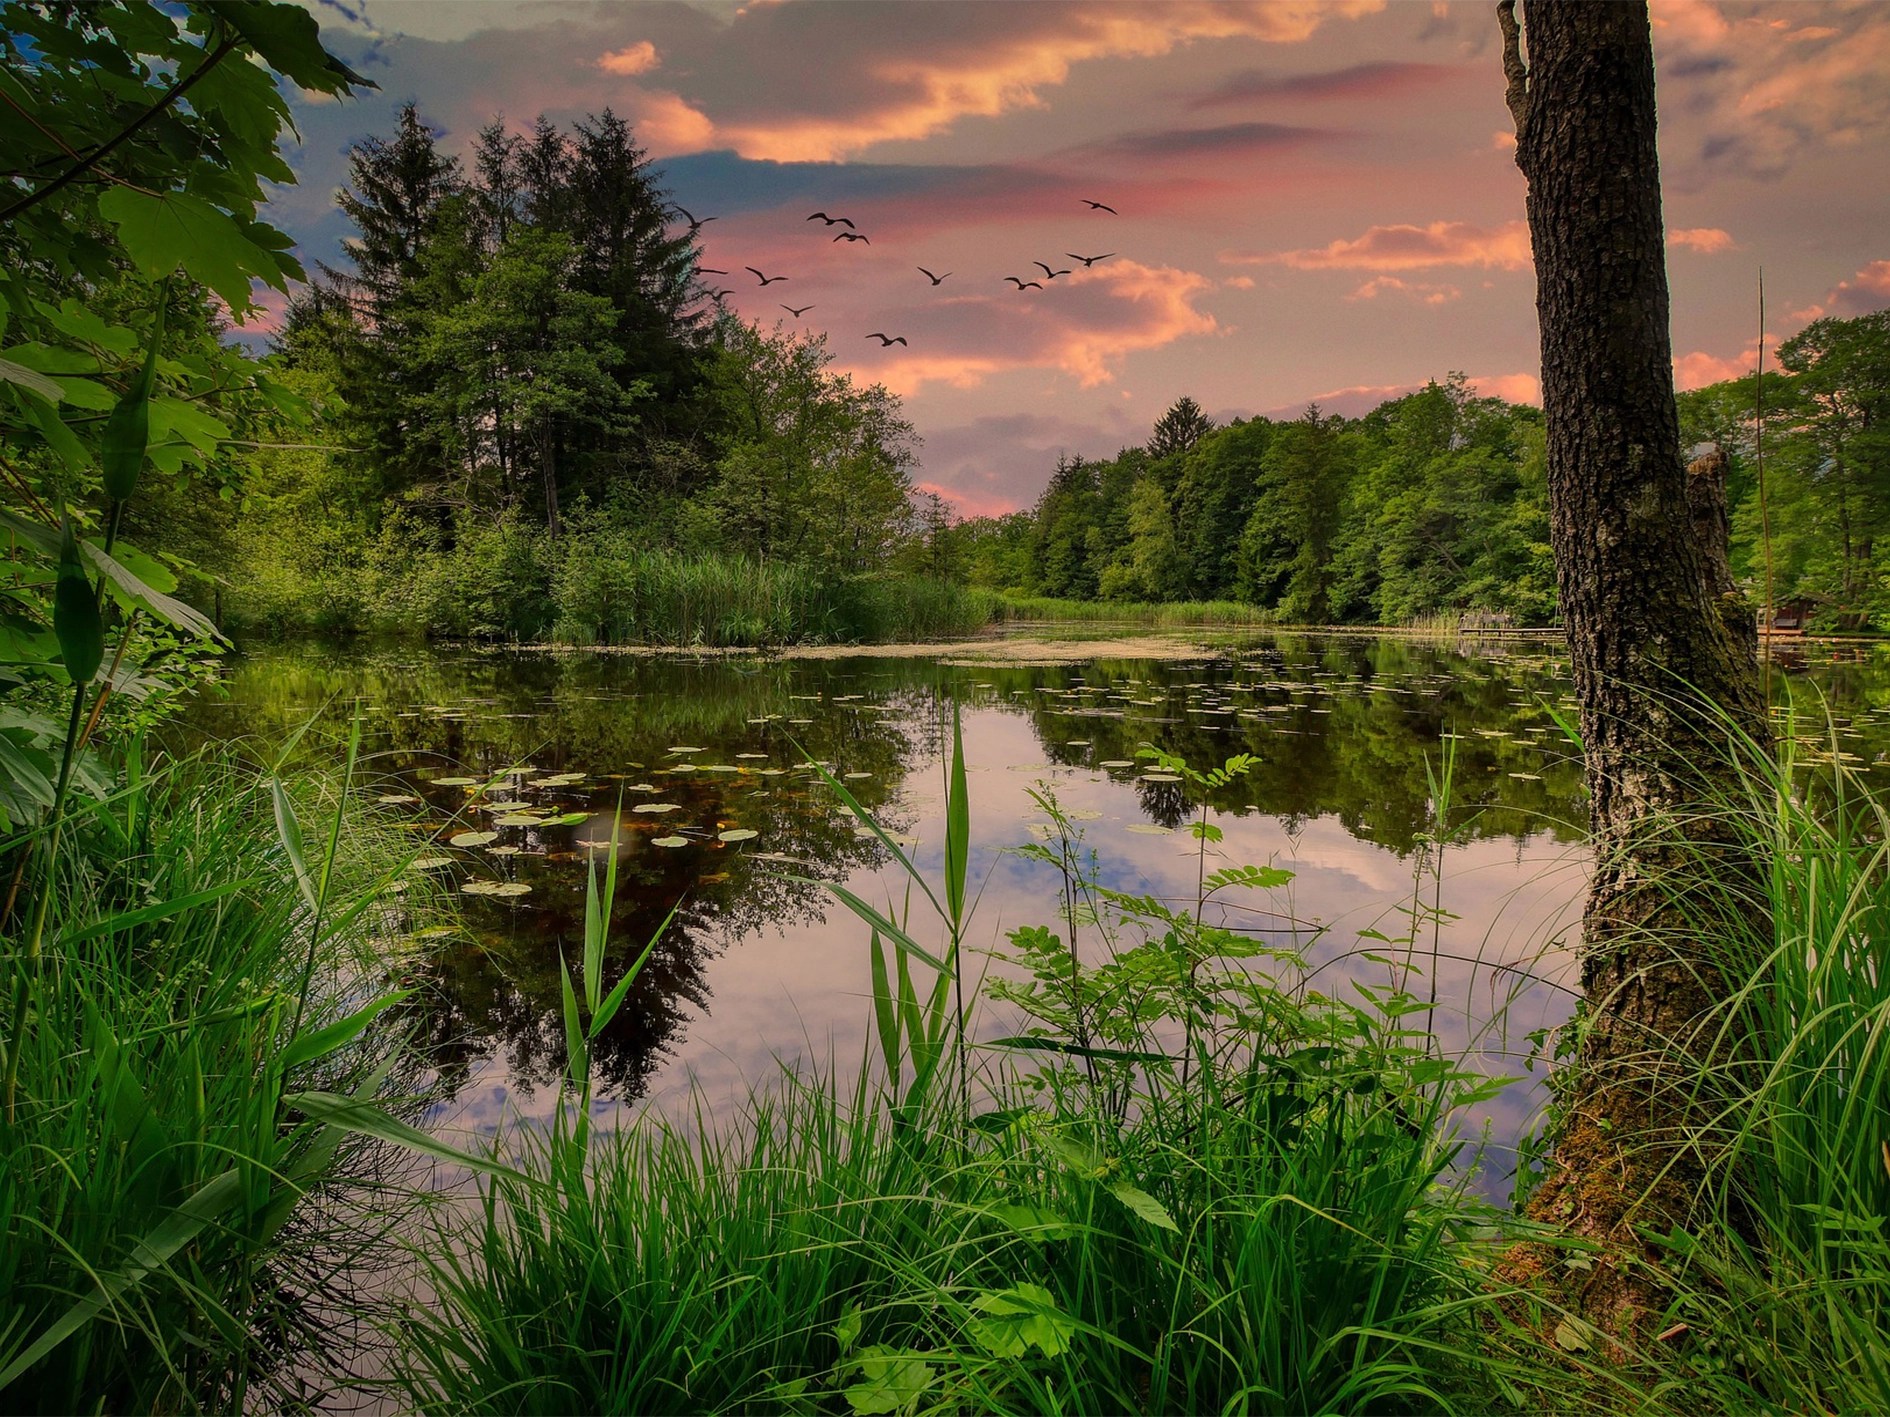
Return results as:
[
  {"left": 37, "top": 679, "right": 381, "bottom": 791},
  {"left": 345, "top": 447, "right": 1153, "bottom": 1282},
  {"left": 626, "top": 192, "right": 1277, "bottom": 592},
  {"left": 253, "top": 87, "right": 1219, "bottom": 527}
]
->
[{"left": 203, "top": 108, "right": 1890, "bottom": 640}]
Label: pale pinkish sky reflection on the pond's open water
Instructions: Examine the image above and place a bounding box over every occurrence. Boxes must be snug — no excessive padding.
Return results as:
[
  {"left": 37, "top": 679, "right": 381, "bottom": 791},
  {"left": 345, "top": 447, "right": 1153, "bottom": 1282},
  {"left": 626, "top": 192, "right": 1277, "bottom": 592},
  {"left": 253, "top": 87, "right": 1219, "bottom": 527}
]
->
[{"left": 434, "top": 695, "right": 1586, "bottom": 1201}]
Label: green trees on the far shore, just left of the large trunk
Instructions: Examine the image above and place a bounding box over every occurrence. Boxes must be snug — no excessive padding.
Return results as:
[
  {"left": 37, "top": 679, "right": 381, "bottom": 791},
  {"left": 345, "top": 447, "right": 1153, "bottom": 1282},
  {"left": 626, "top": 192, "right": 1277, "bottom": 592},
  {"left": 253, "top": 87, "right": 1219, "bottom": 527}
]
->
[{"left": 953, "top": 374, "right": 1555, "bottom": 623}]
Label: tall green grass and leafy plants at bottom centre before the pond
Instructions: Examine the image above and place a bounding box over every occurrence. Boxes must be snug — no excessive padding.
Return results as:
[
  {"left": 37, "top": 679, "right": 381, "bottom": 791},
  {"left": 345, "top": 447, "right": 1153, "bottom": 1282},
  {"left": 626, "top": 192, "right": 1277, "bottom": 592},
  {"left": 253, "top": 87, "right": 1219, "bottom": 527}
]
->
[{"left": 401, "top": 733, "right": 1512, "bottom": 1413}]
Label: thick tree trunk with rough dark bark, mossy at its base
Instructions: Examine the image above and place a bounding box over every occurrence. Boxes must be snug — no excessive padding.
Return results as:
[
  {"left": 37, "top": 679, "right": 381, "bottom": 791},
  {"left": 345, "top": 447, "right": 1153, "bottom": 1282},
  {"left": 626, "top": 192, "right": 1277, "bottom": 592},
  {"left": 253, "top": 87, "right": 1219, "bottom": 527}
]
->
[{"left": 1497, "top": 0, "right": 1765, "bottom": 1338}]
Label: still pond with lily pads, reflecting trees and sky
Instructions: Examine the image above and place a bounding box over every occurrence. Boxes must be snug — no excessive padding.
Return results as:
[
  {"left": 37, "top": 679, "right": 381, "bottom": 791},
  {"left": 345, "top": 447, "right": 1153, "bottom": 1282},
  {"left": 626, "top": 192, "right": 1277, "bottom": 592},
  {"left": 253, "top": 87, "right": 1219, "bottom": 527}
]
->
[{"left": 180, "top": 633, "right": 1890, "bottom": 1192}]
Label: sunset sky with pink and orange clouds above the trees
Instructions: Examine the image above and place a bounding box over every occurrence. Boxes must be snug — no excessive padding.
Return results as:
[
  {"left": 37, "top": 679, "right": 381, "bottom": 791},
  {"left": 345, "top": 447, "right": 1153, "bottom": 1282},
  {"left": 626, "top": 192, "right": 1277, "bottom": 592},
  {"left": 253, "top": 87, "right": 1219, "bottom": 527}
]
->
[{"left": 272, "top": 0, "right": 1890, "bottom": 516}]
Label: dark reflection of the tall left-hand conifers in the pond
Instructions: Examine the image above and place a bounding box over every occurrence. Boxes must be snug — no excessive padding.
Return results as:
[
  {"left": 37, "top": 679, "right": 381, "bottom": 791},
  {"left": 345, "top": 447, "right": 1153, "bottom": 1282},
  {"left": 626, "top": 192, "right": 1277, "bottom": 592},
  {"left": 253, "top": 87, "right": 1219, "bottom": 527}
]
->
[{"left": 195, "top": 646, "right": 937, "bottom": 1100}]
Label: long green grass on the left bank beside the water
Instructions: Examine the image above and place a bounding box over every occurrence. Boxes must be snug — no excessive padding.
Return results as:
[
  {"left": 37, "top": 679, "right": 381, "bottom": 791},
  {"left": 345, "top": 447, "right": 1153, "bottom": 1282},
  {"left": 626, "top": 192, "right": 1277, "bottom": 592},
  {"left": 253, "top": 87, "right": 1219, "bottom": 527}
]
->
[{"left": 0, "top": 758, "right": 429, "bottom": 1413}]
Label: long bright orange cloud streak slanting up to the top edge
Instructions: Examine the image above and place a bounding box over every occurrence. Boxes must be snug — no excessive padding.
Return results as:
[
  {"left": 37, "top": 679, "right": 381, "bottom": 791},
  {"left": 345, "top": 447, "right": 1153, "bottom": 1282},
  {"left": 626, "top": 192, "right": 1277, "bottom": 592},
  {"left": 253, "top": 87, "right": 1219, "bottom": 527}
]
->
[{"left": 722, "top": 0, "right": 1383, "bottom": 162}]
